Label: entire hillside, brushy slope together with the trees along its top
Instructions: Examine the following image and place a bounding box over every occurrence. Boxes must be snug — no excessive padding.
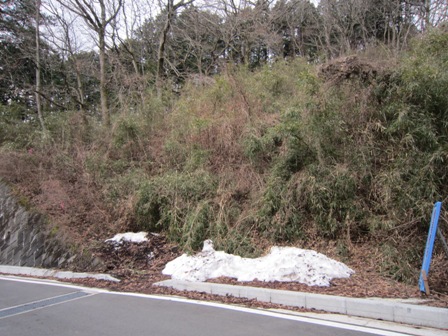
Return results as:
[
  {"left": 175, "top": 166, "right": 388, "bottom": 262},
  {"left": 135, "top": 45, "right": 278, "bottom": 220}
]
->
[{"left": 0, "top": 0, "right": 448, "bottom": 289}]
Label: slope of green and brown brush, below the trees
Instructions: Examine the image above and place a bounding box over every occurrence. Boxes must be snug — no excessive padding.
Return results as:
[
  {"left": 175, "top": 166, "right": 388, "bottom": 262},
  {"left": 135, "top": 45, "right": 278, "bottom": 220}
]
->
[{"left": 0, "top": 31, "right": 448, "bottom": 285}]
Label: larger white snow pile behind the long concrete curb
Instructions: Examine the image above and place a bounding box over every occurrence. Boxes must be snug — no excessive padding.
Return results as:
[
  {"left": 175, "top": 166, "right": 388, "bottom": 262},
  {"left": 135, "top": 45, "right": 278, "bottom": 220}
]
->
[{"left": 162, "top": 240, "right": 354, "bottom": 286}]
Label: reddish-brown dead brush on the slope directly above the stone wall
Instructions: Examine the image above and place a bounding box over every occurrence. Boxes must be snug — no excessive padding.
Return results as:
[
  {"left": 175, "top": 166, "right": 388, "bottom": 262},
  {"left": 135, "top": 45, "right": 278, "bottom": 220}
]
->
[{"left": 0, "top": 149, "right": 122, "bottom": 253}]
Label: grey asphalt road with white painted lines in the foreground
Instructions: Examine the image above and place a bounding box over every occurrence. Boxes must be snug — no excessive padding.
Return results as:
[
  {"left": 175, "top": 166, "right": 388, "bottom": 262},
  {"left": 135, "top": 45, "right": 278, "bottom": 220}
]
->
[{"left": 0, "top": 276, "right": 428, "bottom": 336}]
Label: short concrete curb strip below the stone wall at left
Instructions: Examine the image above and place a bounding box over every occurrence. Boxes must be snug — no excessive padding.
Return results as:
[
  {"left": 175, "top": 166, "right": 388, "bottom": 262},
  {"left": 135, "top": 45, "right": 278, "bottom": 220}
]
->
[{"left": 0, "top": 265, "right": 120, "bottom": 282}]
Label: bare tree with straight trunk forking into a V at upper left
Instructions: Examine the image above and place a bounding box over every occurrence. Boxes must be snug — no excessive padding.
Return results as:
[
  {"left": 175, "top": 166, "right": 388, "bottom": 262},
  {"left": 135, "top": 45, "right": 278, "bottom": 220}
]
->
[{"left": 56, "top": 0, "right": 124, "bottom": 127}]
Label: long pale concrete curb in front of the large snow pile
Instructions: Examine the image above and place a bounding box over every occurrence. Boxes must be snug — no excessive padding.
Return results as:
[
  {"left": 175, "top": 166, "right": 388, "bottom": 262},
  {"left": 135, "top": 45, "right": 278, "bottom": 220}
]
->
[{"left": 155, "top": 280, "right": 448, "bottom": 329}]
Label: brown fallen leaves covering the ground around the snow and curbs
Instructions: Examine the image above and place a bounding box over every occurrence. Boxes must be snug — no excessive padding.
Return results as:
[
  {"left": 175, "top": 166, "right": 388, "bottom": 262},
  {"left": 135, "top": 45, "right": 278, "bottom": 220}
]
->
[{"left": 62, "top": 235, "right": 448, "bottom": 308}]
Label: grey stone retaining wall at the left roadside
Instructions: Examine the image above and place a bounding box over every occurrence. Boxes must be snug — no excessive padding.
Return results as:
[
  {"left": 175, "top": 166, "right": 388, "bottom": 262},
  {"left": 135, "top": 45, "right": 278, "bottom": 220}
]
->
[{"left": 0, "top": 181, "right": 76, "bottom": 268}]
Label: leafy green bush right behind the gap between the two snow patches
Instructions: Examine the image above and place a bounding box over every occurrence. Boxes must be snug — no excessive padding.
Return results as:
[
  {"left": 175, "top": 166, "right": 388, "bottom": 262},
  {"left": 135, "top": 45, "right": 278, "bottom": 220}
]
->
[{"left": 135, "top": 171, "right": 216, "bottom": 249}]
